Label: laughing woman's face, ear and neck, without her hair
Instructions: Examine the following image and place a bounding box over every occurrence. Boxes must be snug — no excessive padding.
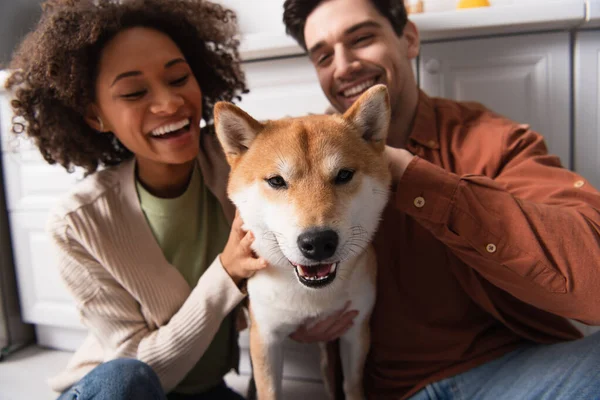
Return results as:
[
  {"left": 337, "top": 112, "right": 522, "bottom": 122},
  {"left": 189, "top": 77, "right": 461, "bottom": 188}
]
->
[{"left": 85, "top": 27, "right": 202, "bottom": 197}]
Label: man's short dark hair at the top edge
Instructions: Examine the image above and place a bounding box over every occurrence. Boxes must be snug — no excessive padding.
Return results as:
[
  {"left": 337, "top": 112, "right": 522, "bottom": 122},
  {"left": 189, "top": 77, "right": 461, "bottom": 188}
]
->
[{"left": 283, "top": 0, "right": 408, "bottom": 50}]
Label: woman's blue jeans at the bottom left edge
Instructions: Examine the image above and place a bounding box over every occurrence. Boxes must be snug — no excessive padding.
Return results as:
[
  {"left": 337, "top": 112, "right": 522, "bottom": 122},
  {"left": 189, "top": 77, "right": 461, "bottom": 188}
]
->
[{"left": 57, "top": 358, "right": 244, "bottom": 400}]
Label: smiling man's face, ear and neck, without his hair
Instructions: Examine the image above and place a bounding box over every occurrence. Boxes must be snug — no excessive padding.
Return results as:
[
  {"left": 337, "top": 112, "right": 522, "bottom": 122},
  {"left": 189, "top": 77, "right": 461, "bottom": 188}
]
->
[{"left": 304, "top": 1, "right": 419, "bottom": 146}]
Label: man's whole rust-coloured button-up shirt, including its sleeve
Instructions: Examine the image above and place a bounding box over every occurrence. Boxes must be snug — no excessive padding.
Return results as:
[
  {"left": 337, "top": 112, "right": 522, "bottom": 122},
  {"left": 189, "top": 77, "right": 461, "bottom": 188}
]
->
[{"left": 365, "top": 93, "right": 600, "bottom": 399}]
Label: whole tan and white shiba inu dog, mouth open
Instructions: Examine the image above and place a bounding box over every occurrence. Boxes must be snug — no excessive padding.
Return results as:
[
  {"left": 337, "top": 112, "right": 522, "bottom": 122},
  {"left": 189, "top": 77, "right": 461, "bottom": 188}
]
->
[{"left": 215, "top": 85, "right": 390, "bottom": 400}]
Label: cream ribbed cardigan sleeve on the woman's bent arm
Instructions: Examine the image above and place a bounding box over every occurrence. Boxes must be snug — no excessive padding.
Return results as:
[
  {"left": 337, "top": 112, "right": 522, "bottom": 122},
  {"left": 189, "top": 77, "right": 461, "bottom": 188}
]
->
[{"left": 50, "top": 219, "right": 245, "bottom": 392}]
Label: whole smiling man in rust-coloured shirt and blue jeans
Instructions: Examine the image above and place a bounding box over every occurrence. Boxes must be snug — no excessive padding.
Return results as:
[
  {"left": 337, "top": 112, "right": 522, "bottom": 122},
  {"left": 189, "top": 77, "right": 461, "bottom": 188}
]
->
[{"left": 284, "top": 0, "right": 600, "bottom": 400}]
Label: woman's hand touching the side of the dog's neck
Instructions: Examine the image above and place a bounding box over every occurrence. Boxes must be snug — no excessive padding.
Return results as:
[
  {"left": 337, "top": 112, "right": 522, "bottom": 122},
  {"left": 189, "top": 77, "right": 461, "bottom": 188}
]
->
[{"left": 220, "top": 211, "right": 268, "bottom": 285}]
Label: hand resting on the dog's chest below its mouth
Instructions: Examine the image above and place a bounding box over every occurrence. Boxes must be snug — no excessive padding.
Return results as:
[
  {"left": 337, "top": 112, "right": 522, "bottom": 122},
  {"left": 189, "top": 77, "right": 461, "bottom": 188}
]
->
[{"left": 290, "top": 302, "right": 358, "bottom": 343}]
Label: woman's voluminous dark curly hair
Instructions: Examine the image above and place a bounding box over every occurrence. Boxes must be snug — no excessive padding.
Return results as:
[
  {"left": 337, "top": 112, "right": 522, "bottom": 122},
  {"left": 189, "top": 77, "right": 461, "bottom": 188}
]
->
[{"left": 6, "top": 0, "right": 248, "bottom": 173}]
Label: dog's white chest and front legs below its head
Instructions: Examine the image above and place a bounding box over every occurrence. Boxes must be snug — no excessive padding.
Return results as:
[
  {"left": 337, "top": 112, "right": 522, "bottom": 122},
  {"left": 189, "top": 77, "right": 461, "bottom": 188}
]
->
[{"left": 248, "top": 247, "right": 375, "bottom": 400}]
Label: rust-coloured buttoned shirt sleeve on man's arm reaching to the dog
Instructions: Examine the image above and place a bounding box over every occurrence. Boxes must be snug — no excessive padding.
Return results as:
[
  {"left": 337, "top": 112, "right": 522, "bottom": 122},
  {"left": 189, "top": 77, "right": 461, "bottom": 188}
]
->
[{"left": 394, "top": 127, "right": 600, "bottom": 324}]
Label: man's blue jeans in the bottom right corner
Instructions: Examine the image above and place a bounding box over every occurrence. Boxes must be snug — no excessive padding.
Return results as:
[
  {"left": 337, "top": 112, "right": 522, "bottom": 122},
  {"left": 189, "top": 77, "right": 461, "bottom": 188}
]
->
[{"left": 410, "top": 332, "right": 600, "bottom": 400}]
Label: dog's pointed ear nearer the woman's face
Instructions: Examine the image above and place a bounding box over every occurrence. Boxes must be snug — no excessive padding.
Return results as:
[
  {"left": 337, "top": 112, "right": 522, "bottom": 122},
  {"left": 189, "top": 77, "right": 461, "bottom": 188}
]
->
[{"left": 214, "top": 101, "right": 263, "bottom": 159}]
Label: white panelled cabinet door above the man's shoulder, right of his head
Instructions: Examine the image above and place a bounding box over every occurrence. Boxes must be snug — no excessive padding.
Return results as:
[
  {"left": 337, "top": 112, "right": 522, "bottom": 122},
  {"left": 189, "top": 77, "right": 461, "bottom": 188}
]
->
[{"left": 419, "top": 32, "right": 572, "bottom": 167}]
